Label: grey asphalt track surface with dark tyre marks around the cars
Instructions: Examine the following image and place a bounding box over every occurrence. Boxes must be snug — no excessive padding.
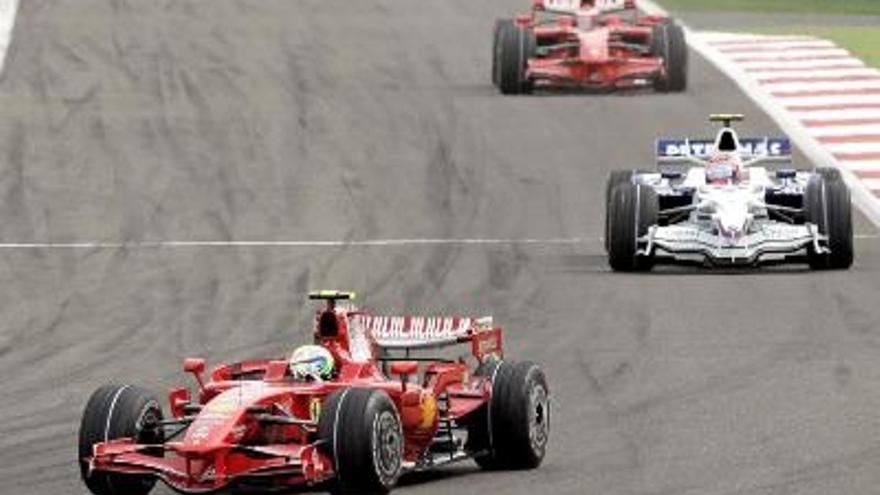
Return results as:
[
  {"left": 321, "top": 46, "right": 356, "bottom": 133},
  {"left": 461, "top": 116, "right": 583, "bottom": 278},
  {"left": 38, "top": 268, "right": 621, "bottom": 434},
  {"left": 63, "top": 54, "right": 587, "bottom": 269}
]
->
[{"left": 0, "top": 0, "right": 880, "bottom": 495}]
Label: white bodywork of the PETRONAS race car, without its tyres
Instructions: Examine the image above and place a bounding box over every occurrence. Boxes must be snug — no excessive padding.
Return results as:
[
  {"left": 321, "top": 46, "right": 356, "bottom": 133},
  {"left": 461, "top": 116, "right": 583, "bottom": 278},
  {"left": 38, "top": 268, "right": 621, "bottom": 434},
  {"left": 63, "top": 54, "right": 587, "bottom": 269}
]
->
[{"left": 636, "top": 122, "right": 826, "bottom": 265}]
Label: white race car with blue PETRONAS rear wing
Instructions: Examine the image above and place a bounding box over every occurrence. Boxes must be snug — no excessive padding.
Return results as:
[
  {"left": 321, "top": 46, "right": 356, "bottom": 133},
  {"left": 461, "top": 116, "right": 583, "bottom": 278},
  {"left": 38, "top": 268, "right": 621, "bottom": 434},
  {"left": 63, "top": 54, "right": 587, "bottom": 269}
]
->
[{"left": 605, "top": 115, "right": 853, "bottom": 271}]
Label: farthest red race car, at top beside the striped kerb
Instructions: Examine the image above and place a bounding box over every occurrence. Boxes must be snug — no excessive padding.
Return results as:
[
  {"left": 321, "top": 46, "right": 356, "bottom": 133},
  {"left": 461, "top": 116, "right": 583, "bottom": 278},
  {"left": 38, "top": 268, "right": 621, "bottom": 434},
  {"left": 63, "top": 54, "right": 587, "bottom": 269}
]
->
[{"left": 492, "top": 0, "right": 688, "bottom": 94}]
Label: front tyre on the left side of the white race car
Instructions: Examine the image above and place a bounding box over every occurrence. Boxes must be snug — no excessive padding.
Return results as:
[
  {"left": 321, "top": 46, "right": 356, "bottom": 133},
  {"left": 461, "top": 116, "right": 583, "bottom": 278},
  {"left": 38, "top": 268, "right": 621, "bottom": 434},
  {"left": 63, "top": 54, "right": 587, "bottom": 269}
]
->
[{"left": 606, "top": 182, "right": 659, "bottom": 272}]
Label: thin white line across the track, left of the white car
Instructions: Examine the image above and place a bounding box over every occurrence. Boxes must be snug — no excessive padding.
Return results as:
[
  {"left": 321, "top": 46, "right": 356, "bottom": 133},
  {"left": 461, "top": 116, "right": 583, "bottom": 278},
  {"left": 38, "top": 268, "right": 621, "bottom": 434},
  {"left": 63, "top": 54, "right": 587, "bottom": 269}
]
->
[{"left": 0, "top": 237, "right": 602, "bottom": 249}]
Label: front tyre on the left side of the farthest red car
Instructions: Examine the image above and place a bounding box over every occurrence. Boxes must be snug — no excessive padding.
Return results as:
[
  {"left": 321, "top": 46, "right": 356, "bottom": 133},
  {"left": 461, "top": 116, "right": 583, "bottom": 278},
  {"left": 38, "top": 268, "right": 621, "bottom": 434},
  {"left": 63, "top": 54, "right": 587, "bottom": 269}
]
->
[{"left": 498, "top": 23, "right": 535, "bottom": 95}]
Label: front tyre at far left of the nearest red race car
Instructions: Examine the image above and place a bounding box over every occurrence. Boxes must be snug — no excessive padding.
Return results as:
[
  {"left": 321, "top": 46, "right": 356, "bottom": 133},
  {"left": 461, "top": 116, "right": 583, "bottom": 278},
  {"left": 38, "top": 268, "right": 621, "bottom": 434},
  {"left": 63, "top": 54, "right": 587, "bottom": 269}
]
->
[{"left": 79, "top": 385, "right": 164, "bottom": 495}]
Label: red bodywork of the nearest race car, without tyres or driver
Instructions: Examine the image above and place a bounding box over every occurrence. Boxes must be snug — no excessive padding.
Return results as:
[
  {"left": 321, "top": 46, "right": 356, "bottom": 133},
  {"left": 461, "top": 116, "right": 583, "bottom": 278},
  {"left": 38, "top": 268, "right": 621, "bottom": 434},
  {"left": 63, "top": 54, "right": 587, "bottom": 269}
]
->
[{"left": 87, "top": 304, "right": 502, "bottom": 493}]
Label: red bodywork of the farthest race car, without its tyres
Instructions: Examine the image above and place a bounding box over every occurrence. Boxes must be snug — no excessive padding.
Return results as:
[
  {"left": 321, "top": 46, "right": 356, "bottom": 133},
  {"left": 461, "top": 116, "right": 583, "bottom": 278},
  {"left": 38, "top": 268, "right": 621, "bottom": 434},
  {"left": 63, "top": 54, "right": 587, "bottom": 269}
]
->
[{"left": 516, "top": 0, "right": 668, "bottom": 89}]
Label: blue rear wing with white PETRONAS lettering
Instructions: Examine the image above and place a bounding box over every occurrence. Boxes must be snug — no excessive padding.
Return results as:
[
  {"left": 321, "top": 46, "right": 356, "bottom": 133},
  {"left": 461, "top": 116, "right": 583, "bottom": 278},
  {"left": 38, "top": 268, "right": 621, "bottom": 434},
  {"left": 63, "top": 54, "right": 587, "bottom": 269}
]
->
[{"left": 655, "top": 137, "right": 792, "bottom": 166}]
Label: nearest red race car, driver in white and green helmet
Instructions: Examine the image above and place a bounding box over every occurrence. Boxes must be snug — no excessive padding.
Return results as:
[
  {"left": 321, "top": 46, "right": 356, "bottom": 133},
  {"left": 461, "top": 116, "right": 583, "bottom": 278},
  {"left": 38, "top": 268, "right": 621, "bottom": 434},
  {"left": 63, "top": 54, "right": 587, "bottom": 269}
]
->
[{"left": 79, "top": 291, "right": 550, "bottom": 495}]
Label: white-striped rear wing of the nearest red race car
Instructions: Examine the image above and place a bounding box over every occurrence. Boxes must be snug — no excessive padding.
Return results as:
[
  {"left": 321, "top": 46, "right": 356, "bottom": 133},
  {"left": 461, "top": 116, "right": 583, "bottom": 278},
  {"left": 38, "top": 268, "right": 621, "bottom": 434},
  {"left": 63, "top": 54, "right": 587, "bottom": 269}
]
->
[{"left": 349, "top": 314, "right": 503, "bottom": 361}]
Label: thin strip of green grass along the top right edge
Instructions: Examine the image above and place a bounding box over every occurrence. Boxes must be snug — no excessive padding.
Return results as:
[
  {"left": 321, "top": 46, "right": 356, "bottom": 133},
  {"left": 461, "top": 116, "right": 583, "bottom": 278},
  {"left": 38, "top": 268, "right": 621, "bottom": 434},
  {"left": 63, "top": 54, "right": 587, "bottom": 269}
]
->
[{"left": 660, "top": 0, "right": 880, "bottom": 15}]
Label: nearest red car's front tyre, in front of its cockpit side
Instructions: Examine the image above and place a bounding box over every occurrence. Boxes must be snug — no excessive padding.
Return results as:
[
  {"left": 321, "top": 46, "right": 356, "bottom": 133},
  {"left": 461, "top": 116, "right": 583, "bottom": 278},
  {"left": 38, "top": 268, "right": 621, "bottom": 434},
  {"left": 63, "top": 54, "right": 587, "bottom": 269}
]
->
[{"left": 318, "top": 388, "right": 404, "bottom": 494}]
